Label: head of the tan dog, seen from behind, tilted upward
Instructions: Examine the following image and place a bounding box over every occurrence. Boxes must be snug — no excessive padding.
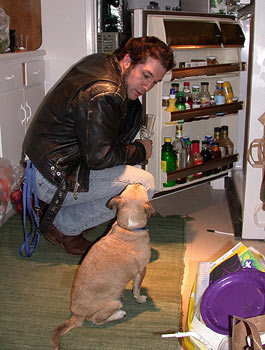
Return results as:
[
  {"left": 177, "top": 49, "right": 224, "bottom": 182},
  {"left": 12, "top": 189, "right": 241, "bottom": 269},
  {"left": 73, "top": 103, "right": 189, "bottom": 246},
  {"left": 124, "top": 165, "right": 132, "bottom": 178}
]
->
[{"left": 107, "top": 184, "right": 155, "bottom": 230}]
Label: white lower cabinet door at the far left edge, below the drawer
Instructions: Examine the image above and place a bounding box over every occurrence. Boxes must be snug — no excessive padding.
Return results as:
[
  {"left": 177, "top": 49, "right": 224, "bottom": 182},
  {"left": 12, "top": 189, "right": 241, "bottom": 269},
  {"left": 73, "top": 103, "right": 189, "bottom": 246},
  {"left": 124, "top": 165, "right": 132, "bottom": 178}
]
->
[{"left": 0, "top": 90, "right": 26, "bottom": 165}]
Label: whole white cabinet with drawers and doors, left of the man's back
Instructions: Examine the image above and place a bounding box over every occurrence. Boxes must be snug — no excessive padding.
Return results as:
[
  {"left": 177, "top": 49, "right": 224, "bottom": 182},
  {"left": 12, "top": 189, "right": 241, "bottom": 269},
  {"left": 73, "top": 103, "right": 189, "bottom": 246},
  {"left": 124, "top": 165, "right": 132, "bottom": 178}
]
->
[{"left": 0, "top": 50, "right": 45, "bottom": 165}]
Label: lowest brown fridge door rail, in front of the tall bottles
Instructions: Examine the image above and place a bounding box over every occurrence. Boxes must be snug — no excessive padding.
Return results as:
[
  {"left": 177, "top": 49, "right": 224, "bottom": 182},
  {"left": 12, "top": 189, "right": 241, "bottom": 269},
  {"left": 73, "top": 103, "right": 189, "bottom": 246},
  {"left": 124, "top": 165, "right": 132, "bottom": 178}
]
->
[{"left": 167, "top": 154, "right": 238, "bottom": 181}]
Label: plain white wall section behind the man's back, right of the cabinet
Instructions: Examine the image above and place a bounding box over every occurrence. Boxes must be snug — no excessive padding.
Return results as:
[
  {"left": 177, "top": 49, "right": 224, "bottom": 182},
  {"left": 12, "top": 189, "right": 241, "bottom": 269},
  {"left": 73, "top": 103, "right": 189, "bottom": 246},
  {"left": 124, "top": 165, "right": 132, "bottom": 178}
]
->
[{"left": 41, "top": 0, "right": 96, "bottom": 92}]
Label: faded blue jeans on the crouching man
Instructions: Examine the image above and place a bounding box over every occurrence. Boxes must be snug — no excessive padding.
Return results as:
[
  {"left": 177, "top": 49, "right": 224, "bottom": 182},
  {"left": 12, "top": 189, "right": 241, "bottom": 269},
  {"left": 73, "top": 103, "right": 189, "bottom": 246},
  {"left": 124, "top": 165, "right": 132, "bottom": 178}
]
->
[{"left": 36, "top": 165, "right": 155, "bottom": 236}]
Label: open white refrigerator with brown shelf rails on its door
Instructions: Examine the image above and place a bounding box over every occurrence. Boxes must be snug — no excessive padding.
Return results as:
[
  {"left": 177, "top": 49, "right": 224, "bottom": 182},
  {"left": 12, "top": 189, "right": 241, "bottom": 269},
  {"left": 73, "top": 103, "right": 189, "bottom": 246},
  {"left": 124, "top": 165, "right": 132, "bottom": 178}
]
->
[{"left": 131, "top": 0, "right": 265, "bottom": 240}]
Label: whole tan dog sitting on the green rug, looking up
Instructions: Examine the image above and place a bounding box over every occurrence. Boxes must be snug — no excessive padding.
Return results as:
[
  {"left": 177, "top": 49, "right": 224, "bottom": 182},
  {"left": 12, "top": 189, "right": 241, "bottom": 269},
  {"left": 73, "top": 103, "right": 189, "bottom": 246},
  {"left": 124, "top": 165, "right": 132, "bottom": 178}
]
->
[{"left": 51, "top": 184, "right": 155, "bottom": 350}]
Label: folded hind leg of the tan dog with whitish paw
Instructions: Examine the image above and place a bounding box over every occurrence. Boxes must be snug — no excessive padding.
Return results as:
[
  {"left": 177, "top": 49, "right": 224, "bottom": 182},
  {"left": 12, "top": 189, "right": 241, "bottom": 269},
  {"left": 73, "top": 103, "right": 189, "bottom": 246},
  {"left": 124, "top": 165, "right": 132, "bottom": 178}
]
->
[{"left": 91, "top": 300, "right": 126, "bottom": 325}]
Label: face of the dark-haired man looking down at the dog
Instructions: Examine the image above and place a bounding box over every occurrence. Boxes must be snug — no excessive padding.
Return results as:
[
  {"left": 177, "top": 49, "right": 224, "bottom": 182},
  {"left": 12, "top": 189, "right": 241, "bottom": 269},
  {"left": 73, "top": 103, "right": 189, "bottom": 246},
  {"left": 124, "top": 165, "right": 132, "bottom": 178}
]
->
[{"left": 123, "top": 57, "right": 166, "bottom": 100}]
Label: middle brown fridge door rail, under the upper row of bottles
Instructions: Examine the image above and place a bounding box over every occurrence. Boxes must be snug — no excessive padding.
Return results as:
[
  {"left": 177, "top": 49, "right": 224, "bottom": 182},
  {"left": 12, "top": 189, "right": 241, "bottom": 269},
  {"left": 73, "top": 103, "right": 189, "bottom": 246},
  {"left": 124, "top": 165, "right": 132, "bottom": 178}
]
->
[{"left": 168, "top": 101, "right": 243, "bottom": 122}]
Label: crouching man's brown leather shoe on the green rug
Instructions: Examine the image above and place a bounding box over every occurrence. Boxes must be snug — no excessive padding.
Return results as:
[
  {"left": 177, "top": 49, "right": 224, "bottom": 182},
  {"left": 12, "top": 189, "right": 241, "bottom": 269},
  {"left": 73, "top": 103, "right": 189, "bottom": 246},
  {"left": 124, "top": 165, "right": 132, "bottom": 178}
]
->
[{"left": 44, "top": 225, "right": 92, "bottom": 256}]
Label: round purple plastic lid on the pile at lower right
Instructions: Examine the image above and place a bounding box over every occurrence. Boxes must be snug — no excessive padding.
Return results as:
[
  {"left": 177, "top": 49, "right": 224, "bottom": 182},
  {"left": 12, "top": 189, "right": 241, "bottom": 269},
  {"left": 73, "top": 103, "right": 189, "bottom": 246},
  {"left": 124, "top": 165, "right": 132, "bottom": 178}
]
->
[{"left": 200, "top": 268, "right": 265, "bottom": 335}]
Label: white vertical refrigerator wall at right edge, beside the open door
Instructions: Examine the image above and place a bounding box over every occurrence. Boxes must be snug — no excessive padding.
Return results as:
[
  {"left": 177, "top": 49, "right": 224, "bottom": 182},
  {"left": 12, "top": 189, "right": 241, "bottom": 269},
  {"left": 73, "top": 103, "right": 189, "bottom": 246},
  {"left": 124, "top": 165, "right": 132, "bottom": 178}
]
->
[{"left": 242, "top": 0, "right": 265, "bottom": 239}]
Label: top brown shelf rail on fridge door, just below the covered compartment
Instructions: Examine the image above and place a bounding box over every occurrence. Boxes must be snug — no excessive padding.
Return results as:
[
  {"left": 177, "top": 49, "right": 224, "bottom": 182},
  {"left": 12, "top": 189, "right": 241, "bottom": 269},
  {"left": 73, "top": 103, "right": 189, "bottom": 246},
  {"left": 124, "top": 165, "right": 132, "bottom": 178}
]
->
[{"left": 171, "top": 62, "right": 246, "bottom": 80}]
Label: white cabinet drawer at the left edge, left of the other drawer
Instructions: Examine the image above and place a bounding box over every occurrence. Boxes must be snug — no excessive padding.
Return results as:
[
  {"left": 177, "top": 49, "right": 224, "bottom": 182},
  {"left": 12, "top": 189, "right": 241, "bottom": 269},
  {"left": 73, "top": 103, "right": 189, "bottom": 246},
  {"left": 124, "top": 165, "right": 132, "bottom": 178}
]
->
[{"left": 0, "top": 64, "right": 23, "bottom": 93}]
